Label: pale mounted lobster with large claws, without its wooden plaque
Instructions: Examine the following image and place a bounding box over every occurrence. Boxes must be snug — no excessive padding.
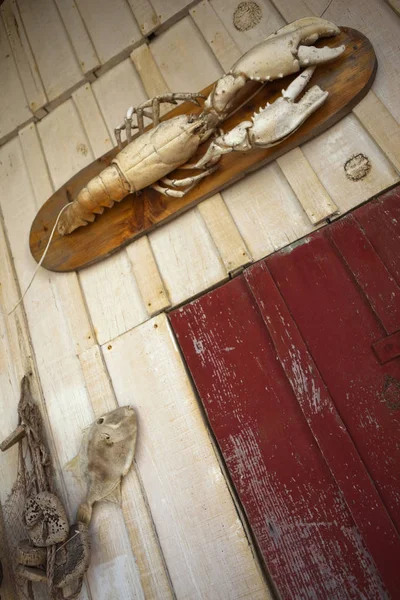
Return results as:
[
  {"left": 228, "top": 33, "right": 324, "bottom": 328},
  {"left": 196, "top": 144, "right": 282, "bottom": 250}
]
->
[{"left": 58, "top": 17, "right": 345, "bottom": 235}]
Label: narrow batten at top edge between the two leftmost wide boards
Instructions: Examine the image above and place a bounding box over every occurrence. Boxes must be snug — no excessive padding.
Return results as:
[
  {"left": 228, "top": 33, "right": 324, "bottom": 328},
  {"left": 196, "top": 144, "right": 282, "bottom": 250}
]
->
[{"left": 55, "top": 0, "right": 100, "bottom": 75}]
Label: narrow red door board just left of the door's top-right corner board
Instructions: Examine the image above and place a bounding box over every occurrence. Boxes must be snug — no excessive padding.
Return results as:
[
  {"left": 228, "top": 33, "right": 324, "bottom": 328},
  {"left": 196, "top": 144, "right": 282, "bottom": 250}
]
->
[{"left": 328, "top": 215, "right": 400, "bottom": 334}]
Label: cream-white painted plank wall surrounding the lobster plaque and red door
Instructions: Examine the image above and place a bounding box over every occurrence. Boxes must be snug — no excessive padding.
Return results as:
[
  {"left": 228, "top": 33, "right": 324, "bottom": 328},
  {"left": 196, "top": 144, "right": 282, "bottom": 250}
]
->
[{"left": 0, "top": 0, "right": 400, "bottom": 600}]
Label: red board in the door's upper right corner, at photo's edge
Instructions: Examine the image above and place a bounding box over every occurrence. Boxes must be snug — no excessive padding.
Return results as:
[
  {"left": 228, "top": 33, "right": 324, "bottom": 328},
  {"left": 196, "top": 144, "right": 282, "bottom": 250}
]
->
[{"left": 354, "top": 186, "right": 400, "bottom": 285}]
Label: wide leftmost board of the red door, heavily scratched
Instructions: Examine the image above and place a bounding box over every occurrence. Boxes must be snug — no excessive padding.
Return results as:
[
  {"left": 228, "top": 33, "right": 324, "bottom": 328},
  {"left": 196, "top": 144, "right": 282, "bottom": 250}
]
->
[{"left": 170, "top": 277, "right": 390, "bottom": 600}]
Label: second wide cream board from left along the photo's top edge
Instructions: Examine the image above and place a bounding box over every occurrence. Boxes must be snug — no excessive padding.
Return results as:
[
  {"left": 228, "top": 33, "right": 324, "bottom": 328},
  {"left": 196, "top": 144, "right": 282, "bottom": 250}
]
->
[{"left": 75, "top": 0, "right": 141, "bottom": 65}]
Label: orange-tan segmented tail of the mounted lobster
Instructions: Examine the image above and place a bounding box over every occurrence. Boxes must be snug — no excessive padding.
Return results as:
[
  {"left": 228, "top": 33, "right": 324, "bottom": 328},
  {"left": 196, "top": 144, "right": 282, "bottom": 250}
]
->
[{"left": 57, "top": 164, "right": 130, "bottom": 235}]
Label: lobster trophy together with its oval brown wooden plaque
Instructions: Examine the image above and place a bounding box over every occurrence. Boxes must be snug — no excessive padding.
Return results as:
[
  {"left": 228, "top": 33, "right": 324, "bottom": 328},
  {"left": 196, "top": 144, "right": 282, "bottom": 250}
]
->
[{"left": 31, "top": 17, "right": 376, "bottom": 271}]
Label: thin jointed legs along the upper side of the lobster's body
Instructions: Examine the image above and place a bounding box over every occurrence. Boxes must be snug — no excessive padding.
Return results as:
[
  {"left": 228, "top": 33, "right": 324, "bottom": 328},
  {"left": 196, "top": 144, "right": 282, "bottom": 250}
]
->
[{"left": 114, "top": 93, "right": 204, "bottom": 149}]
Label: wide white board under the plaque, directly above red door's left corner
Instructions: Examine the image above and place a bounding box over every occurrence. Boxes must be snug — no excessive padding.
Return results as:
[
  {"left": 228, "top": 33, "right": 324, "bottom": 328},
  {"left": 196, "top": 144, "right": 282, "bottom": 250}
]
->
[{"left": 149, "top": 211, "right": 228, "bottom": 305}]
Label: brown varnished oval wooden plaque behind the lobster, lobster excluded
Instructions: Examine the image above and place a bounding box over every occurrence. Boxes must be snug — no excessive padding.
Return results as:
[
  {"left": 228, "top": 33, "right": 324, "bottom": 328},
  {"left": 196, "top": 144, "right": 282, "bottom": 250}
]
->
[{"left": 30, "top": 26, "right": 376, "bottom": 270}]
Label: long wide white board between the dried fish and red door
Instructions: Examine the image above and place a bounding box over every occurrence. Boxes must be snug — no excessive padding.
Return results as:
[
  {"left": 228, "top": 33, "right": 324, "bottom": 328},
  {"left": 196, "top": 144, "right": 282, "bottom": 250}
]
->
[{"left": 104, "top": 315, "right": 269, "bottom": 600}]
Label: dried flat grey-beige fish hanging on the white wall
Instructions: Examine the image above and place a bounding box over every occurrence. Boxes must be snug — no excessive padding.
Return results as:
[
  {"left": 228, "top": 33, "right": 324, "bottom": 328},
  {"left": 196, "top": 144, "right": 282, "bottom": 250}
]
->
[{"left": 66, "top": 406, "right": 137, "bottom": 525}]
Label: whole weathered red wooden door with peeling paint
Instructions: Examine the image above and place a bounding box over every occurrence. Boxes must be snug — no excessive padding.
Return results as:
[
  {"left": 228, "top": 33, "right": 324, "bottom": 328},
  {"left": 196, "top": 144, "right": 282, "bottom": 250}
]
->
[{"left": 170, "top": 187, "right": 400, "bottom": 600}]
